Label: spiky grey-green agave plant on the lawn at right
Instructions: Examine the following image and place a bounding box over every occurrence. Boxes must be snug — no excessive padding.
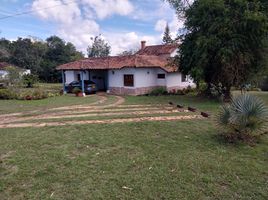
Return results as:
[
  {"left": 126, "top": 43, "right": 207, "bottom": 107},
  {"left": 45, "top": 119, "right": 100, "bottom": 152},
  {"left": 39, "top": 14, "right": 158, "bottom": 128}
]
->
[{"left": 217, "top": 94, "right": 268, "bottom": 139}]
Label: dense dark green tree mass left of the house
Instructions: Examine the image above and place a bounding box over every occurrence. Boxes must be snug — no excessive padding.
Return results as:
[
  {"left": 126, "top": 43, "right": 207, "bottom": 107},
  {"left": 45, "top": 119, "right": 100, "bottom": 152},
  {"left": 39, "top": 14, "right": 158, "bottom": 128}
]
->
[{"left": 0, "top": 36, "right": 84, "bottom": 82}]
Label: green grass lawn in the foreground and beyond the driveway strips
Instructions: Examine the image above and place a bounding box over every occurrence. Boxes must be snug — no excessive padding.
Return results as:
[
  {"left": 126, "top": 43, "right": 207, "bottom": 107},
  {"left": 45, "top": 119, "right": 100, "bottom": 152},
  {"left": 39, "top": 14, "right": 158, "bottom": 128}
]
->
[{"left": 0, "top": 93, "right": 268, "bottom": 200}]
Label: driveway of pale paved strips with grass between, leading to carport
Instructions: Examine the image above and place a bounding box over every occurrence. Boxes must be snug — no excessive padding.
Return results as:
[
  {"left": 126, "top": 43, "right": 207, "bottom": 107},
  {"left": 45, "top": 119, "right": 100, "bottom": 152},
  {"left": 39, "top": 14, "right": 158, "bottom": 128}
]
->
[{"left": 0, "top": 94, "right": 202, "bottom": 128}]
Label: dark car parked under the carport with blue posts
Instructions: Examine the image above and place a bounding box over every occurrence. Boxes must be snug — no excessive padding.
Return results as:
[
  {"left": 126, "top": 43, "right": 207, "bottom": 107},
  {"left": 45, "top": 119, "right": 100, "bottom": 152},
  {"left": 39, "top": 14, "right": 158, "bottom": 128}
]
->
[{"left": 65, "top": 80, "right": 97, "bottom": 94}]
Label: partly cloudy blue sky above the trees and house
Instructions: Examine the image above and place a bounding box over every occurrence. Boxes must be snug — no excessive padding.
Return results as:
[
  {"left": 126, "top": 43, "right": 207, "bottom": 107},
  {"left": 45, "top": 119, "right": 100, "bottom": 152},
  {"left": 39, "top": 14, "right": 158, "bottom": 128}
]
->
[{"left": 0, "top": 0, "right": 183, "bottom": 55}]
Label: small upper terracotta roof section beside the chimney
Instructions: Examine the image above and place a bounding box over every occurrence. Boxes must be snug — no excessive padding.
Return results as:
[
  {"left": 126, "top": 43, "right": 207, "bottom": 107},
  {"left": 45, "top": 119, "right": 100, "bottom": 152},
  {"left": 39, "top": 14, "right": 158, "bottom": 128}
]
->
[{"left": 137, "top": 44, "right": 179, "bottom": 56}]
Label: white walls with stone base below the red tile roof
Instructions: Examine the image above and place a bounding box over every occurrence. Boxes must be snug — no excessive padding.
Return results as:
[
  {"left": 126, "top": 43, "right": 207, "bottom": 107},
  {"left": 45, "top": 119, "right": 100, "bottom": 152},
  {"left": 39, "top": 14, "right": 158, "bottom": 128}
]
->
[{"left": 65, "top": 68, "right": 195, "bottom": 94}]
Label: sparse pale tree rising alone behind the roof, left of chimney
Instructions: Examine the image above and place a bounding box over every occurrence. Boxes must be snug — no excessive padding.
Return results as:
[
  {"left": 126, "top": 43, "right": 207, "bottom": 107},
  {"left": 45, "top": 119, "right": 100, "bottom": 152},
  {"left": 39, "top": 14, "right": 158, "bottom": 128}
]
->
[{"left": 87, "top": 36, "right": 111, "bottom": 57}]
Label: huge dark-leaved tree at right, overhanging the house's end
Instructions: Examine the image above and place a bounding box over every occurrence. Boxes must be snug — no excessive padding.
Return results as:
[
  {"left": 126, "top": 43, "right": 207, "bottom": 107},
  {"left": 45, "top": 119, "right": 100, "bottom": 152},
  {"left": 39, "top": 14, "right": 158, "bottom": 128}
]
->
[{"left": 170, "top": 0, "right": 268, "bottom": 98}]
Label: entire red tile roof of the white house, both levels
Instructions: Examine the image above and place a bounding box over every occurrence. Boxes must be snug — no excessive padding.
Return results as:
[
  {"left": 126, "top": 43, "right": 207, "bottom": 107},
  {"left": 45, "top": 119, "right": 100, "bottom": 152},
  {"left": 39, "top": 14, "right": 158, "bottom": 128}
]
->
[{"left": 57, "top": 44, "right": 178, "bottom": 72}]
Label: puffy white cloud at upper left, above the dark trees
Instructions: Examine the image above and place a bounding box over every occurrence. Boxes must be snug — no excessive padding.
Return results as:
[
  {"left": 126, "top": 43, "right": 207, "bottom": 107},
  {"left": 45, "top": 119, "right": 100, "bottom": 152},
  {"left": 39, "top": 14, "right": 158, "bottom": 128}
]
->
[{"left": 32, "top": 0, "right": 100, "bottom": 51}]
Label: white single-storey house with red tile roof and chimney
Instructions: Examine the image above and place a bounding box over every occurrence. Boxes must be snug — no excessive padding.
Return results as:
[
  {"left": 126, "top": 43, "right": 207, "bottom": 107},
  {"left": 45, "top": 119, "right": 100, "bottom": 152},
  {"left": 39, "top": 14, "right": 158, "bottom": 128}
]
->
[{"left": 57, "top": 41, "right": 195, "bottom": 95}]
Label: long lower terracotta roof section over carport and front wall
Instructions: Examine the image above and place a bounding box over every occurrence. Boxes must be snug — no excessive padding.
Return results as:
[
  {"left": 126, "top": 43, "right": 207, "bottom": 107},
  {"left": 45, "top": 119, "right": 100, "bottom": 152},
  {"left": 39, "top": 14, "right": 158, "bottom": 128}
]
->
[{"left": 57, "top": 54, "right": 176, "bottom": 72}]
